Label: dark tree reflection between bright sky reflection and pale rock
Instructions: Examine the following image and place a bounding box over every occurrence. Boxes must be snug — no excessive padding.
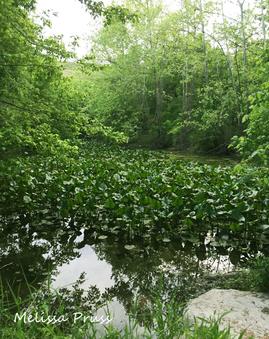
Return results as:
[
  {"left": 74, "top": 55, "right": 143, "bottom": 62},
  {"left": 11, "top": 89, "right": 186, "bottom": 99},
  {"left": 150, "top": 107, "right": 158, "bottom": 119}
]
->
[{"left": 81, "top": 231, "right": 260, "bottom": 322}]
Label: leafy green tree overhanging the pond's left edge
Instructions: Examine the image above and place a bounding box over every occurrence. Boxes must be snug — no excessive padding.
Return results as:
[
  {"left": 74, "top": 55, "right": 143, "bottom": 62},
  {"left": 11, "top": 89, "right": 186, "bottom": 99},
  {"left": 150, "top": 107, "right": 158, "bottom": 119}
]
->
[{"left": 0, "top": 0, "right": 126, "bottom": 158}]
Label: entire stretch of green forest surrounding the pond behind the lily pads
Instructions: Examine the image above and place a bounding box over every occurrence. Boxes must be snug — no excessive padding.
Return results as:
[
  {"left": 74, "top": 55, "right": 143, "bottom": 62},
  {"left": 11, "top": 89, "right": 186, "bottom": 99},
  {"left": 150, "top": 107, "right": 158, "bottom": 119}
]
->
[{"left": 0, "top": 0, "right": 269, "bottom": 165}]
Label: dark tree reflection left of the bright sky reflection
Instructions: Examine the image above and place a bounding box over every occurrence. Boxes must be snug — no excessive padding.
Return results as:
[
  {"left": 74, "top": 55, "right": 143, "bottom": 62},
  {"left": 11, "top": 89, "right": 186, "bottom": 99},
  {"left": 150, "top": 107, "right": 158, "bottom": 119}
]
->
[{"left": 0, "top": 219, "right": 79, "bottom": 297}]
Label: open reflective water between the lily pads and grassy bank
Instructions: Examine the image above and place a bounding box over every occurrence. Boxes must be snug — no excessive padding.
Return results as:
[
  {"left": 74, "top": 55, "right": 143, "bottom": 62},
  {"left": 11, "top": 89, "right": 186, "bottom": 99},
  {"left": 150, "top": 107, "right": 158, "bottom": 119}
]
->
[{"left": 0, "top": 215, "right": 262, "bottom": 330}]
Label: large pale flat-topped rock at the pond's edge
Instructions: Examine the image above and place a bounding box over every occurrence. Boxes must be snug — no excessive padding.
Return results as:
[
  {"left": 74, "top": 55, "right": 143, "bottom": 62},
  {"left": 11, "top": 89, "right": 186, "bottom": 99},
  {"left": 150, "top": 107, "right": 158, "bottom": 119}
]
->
[{"left": 186, "top": 289, "right": 269, "bottom": 339}]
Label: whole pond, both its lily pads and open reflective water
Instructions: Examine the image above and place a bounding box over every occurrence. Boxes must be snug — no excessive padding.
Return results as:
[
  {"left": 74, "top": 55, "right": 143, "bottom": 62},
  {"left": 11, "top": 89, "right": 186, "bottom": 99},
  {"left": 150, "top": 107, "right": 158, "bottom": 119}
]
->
[{"left": 0, "top": 147, "right": 269, "bottom": 327}]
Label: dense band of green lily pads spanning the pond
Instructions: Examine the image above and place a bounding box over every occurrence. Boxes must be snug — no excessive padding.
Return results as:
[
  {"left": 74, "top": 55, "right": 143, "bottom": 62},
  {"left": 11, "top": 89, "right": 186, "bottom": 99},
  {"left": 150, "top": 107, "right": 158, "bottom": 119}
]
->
[{"left": 0, "top": 146, "right": 269, "bottom": 241}]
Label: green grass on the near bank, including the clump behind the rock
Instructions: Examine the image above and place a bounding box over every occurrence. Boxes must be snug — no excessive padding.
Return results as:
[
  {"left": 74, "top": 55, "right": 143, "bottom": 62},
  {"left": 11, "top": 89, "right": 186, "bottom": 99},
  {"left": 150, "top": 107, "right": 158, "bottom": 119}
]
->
[{"left": 0, "top": 251, "right": 269, "bottom": 339}]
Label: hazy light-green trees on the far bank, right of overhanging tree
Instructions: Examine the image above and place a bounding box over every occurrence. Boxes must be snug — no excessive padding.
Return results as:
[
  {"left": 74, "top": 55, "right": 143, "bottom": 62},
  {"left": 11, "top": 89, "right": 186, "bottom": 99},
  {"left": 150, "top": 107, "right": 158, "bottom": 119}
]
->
[{"left": 76, "top": 0, "right": 268, "bottom": 157}]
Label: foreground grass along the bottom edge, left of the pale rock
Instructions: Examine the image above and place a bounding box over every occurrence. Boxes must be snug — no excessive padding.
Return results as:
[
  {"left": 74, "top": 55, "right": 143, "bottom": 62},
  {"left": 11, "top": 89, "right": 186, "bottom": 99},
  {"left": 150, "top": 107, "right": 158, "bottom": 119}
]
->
[{"left": 0, "top": 281, "right": 239, "bottom": 339}]
